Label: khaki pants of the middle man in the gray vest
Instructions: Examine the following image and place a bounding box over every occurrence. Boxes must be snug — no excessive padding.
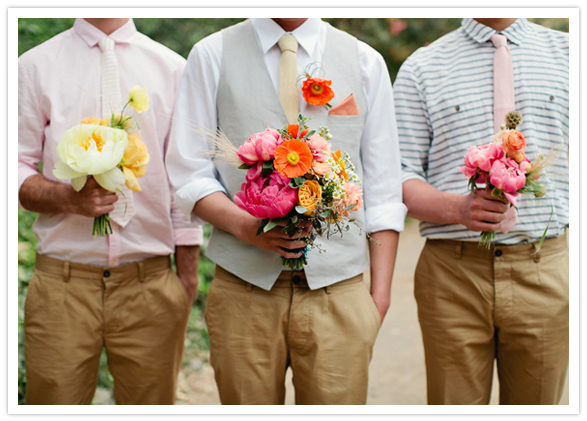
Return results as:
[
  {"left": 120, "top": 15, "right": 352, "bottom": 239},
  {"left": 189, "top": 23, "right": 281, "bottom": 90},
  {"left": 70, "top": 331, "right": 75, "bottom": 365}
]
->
[{"left": 206, "top": 267, "right": 380, "bottom": 405}]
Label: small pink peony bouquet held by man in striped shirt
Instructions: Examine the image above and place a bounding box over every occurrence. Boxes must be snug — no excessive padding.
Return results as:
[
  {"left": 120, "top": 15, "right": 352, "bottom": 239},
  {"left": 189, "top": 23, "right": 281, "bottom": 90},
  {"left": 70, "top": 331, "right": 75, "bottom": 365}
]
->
[{"left": 459, "top": 111, "right": 554, "bottom": 248}]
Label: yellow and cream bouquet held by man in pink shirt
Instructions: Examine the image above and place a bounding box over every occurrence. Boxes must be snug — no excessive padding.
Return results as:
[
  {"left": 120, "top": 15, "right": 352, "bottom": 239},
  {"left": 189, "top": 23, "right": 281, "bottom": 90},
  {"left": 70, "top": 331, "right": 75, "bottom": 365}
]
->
[{"left": 53, "top": 86, "right": 150, "bottom": 236}]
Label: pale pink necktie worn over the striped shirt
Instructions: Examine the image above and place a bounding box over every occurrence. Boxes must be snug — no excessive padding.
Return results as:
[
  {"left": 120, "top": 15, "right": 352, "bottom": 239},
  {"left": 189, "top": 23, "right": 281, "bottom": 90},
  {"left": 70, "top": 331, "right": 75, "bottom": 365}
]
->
[{"left": 491, "top": 34, "right": 516, "bottom": 133}]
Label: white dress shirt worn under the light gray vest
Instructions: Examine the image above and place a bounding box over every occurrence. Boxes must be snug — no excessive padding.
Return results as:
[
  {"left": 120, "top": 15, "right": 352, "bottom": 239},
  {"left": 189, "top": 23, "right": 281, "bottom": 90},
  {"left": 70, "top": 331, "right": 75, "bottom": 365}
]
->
[{"left": 166, "top": 18, "right": 407, "bottom": 232}]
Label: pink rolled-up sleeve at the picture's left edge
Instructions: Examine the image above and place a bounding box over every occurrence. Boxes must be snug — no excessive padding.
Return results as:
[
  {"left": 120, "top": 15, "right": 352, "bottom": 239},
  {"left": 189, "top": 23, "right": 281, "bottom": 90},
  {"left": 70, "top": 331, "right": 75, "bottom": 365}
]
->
[{"left": 18, "top": 59, "right": 47, "bottom": 204}]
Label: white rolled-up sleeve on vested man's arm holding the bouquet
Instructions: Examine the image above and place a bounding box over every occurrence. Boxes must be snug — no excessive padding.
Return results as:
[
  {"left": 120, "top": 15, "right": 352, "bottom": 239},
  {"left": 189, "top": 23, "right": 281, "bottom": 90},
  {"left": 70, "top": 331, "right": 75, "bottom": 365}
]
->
[{"left": 166, "top": 33, "right": 226, "bottom": 223}]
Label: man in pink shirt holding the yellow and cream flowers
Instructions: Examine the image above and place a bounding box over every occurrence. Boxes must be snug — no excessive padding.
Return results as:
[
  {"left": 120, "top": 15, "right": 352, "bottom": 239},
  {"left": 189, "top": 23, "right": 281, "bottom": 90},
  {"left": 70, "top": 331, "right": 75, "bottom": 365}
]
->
[{"left": 18, "top": 18, "right": 202, "bottom": 404}]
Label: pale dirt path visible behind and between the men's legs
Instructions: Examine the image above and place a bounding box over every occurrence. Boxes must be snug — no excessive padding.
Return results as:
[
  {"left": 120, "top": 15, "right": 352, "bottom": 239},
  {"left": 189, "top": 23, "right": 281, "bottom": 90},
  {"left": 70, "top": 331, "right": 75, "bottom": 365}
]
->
[{"left": 177, "top": 222, "right": 569, "bottom": 405}]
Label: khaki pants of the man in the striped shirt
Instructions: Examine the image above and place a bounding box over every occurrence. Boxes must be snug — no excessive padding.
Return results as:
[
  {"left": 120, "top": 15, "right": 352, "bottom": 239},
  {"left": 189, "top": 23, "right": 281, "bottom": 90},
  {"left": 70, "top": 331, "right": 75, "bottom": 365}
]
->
[{"left": 415, "top": 235, "right": 569, "bottom": 405}]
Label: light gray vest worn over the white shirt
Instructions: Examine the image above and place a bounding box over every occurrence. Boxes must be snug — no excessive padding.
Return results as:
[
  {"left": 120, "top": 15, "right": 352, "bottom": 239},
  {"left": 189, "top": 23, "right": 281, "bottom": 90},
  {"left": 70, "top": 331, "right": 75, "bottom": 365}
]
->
[{"left": 206, "top": 20, "right": 369, "bottom": 290}]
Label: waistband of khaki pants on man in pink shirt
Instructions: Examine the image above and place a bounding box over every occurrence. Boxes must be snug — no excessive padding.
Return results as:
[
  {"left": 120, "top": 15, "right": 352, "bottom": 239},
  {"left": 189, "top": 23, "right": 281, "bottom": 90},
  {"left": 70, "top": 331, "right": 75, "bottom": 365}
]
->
[{"left": 35, "top": 254, "right": 171, "bottom": 282}]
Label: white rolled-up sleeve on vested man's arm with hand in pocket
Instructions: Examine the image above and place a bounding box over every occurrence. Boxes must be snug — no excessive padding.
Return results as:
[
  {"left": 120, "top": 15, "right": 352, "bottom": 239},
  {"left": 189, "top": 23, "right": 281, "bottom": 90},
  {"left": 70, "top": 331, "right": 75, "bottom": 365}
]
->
[{"left": 359, "top": 43, "right": 407, "bottom": 232}]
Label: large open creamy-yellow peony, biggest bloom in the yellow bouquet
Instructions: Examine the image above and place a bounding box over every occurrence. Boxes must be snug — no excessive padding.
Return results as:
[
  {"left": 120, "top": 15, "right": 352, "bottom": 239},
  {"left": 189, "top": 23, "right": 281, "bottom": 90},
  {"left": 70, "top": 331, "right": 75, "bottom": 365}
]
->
[{"left": 53, "top": 124, "right": 128, "bottom": 191}]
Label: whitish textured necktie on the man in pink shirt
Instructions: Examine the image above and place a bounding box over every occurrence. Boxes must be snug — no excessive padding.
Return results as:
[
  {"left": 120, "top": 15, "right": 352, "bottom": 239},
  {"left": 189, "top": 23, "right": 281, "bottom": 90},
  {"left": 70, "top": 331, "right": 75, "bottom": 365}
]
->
[{"left": 98, "top": 37, "right": 136, "bottom": 227}]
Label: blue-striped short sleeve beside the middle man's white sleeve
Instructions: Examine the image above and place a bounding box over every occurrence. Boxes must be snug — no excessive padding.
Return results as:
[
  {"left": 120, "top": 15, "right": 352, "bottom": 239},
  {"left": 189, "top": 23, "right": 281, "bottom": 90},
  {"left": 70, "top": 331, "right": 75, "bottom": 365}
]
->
[{"left": 393, "top": 59, "right": 432, "bottom": 182}]
